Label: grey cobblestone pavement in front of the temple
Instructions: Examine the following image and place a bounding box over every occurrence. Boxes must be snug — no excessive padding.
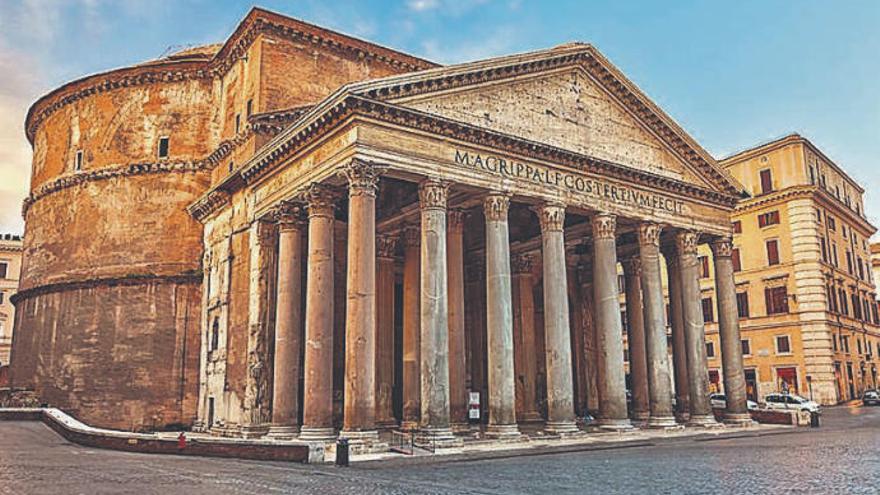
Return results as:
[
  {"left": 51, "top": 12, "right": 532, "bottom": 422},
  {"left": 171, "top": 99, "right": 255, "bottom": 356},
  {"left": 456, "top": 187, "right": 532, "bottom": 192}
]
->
[{"left": 0, "top": 407, "right": 880, "bottom": 495}]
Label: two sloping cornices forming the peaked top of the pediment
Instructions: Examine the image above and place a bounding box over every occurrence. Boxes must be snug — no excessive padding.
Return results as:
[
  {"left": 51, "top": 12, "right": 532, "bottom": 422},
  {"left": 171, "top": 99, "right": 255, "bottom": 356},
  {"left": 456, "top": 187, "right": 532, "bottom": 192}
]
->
[{"left": 352, "top": 45, "right": 744, "bottom": 195}]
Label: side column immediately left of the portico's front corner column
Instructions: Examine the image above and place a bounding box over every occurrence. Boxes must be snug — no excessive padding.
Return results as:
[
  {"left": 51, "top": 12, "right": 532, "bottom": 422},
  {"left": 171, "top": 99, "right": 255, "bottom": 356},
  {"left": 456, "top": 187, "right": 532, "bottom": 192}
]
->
[{"left": 300, "top": 184, "right": 334, "bottom": 440}]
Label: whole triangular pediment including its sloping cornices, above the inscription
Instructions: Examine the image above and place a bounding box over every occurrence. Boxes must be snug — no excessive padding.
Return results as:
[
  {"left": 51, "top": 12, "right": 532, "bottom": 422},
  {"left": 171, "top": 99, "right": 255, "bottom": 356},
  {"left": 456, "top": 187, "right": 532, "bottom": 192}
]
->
[{"left": 350, "top": 44, "right": 742, "bottom": 195}]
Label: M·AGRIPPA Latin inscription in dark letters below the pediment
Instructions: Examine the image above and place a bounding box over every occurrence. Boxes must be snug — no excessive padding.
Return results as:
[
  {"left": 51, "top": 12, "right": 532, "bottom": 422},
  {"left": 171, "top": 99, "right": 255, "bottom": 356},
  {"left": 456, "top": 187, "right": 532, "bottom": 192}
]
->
[{"left": 455, "top": 150, "right": 684, "bottom": 214}]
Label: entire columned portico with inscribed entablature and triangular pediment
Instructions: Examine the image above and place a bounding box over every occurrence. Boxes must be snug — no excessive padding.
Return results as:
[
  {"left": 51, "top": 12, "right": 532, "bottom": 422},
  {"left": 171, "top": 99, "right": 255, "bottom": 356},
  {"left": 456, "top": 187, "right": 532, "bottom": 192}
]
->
[{"left": 191, "top": 45, "right": 745, "bottom": 448}]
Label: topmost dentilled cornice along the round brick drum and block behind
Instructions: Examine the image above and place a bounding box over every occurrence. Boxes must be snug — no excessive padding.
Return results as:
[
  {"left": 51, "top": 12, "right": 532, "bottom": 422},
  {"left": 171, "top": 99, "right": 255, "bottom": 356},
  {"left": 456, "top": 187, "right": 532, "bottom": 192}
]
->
[{"left": 25, "top": 8, "right": 437, "bottom": 143}]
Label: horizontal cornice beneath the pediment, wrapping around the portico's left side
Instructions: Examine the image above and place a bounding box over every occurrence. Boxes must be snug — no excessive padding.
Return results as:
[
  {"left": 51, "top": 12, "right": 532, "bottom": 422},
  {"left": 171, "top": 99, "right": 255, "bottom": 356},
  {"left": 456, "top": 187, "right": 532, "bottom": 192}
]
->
[{"left": 190, "top": 95, "right": 739, "bottom": 222}]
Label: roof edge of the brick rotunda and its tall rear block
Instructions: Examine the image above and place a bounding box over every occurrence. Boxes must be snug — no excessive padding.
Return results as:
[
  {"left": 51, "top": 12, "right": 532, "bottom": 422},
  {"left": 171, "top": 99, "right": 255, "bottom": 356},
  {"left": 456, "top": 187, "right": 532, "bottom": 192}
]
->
[{"left": 24, "top": 7, "right": 439, "bottom": 144}]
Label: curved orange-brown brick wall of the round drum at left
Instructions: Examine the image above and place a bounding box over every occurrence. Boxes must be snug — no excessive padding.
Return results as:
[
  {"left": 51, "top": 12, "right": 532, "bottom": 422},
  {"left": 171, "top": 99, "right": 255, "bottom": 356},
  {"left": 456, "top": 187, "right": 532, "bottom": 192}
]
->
[{"left": 11, "top": 62, "right": 217, "bottom": 430}]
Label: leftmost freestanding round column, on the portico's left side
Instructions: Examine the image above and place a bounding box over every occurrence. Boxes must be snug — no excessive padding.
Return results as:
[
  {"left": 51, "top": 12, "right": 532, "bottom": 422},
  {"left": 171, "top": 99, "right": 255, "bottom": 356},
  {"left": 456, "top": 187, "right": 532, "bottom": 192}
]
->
[{"left": 269, "top": 206, "right": 303, "bottom": 438}]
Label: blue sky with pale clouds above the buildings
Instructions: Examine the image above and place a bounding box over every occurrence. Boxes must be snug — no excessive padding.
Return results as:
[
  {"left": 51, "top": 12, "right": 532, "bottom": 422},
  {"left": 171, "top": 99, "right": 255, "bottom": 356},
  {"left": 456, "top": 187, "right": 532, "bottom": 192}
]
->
[{"left": 0, "top": 0, "right": 880, "bottom": 233}]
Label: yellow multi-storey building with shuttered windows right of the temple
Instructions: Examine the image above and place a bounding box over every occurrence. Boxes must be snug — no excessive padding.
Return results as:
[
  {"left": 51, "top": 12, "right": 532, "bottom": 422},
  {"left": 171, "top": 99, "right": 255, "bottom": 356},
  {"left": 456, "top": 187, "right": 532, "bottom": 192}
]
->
[{"left": 701, "top": 134, "right": 880, "bottom": 404}]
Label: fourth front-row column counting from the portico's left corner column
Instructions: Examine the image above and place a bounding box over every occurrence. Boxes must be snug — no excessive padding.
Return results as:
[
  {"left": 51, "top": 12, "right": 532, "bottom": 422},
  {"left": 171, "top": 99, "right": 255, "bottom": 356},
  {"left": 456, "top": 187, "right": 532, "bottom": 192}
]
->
[{"left": 538, "top": 204, "right": 578, "bottom": 434}]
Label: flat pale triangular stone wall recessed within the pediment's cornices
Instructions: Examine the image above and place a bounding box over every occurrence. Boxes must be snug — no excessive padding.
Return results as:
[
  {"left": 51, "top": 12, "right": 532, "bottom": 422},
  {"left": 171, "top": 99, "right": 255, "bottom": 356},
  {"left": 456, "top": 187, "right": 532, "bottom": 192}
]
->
[{"left": 399, "top": 67, "right": 711, "bottom": 187}]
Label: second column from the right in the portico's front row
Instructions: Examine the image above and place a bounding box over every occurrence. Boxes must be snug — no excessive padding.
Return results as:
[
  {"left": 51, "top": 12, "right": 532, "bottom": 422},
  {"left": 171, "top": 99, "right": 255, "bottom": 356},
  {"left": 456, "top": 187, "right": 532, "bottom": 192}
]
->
[{"left": 676, "top": 231, "right": 715, "bottom": 426}]
